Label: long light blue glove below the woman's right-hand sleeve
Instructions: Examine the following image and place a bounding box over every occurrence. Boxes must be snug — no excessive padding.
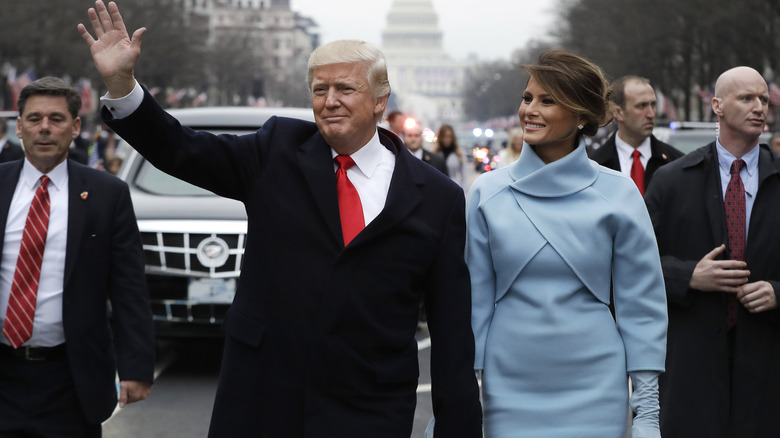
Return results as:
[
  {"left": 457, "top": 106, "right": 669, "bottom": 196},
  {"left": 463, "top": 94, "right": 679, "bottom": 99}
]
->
[{"left": 628, "top": 371, "right": 661, "bottom": 438}]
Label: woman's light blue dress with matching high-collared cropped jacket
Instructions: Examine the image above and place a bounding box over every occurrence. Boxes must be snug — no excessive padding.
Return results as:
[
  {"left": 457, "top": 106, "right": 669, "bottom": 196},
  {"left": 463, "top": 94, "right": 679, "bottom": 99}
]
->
[{"left": 466, "top": 144, "right": 667, "bottom": 436}]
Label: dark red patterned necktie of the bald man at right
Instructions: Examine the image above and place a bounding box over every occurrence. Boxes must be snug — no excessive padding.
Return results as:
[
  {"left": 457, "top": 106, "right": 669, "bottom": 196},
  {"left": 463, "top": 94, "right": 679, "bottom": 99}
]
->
[{"left": 723, "top": 160, "right": 747, "bottom": 328}]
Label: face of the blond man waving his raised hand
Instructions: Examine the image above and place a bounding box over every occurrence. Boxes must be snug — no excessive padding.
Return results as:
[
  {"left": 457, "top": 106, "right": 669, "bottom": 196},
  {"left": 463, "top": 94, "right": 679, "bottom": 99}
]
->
[{"left": 311, "top": 62, "right": 388, "bottom": 155}]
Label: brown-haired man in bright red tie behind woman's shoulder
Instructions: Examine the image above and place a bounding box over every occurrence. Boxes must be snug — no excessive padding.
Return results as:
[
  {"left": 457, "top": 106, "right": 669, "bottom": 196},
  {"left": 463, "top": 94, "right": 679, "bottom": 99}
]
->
[{"left": 589, "top": 76, "right": 684, "bottom": 192}]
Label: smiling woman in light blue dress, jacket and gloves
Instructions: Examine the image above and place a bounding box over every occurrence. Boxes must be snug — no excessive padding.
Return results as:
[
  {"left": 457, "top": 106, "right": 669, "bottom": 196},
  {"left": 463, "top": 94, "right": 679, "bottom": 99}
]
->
[{"left": 466, "top": 50, "right": 667, "bottom": 438}]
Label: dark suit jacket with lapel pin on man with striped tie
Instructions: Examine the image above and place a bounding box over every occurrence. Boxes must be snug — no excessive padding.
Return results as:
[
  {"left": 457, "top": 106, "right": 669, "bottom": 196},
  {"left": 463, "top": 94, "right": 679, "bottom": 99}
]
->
[{"left": 0, "top": 160, "right": 154, "bottom": 423}]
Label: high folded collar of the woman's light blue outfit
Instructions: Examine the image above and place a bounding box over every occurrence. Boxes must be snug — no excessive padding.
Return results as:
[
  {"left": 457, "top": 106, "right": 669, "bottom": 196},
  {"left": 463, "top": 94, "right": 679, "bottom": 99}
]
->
[{"left": 510, "top": 141, "right": 598, "bottom": 197}]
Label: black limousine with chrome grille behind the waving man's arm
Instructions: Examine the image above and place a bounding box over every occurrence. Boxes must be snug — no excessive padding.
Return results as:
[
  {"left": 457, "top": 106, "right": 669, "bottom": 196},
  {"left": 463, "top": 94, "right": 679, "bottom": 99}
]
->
[{"left": 117, "top": 107, "right": 314, "bottom": 338}]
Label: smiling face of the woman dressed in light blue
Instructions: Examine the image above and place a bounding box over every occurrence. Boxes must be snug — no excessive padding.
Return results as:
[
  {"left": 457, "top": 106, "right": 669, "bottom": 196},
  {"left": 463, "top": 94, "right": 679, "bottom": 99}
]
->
[{"left": 518, "top": 78, "right": 580, "bottom": 155}]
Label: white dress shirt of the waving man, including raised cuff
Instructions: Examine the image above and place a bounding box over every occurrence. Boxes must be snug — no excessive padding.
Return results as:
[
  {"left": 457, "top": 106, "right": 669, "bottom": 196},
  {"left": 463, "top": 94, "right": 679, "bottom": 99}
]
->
[{"left": 100, "top": 81, "right": 395, "bottom": 226}]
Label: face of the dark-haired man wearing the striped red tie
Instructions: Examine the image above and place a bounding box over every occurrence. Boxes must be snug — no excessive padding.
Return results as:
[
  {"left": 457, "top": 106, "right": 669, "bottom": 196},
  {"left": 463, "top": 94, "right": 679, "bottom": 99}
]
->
[{"left": 16, "top": 95, "right": 81, "bottom": 173}]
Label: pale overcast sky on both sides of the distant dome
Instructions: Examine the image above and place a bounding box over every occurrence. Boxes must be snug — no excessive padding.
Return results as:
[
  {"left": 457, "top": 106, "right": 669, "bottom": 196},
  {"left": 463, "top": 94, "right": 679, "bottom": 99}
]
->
[{"left": 290, "top": 0, "right": 557, "bottom": 60}]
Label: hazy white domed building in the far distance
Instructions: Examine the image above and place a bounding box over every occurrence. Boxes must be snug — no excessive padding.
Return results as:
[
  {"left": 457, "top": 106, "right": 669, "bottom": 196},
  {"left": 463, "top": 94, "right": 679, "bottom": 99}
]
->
[{"left": 382, "top": 0, "right": 473, "bottom": 125}]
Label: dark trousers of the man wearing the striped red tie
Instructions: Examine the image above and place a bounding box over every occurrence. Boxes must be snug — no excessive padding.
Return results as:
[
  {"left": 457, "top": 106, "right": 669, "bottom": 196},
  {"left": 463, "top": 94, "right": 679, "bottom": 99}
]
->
[{"left": 0, "top": 357, "right": 102, "bottom": 438}]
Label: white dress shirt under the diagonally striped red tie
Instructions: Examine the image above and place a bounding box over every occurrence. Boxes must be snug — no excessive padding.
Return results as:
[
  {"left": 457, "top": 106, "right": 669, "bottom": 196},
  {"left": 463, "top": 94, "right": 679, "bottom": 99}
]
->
[{"left": 0, "top": 159, "right": 68, "bottom": 347}]
